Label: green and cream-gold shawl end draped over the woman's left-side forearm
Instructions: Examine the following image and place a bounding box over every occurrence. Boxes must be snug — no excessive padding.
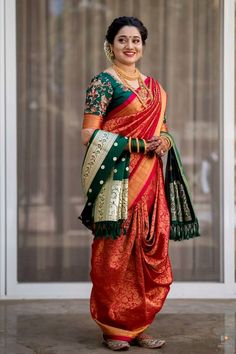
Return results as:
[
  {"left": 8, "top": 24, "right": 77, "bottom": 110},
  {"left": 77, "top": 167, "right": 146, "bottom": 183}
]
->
[{"left": 79, "top": 130, "right": 130, "bottom": 239}]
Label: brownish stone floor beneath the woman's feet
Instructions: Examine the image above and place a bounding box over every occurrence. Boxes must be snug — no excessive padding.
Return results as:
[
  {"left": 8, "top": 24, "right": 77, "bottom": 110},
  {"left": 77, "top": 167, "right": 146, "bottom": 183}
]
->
[{"left": 0, "top": 300, "right": 236, "bottom": 354}]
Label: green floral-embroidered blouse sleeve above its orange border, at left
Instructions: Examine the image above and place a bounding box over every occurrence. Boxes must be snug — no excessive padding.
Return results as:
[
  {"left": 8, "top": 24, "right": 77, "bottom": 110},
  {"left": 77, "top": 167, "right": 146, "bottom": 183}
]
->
[{"left": 84, "top": 74, "right": 113, "bottom": 117}]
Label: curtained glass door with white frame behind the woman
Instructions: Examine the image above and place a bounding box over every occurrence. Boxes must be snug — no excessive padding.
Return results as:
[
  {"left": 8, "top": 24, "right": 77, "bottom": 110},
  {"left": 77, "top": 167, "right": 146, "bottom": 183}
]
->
[{"left": 5, "top": 0, "right": 232, "bottom": 298}]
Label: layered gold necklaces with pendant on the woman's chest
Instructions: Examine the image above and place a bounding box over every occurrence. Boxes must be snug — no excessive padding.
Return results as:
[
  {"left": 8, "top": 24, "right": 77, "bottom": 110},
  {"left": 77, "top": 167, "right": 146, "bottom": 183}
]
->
[{"left": 113, "top": 65, "right": 153, "bottom": 107}]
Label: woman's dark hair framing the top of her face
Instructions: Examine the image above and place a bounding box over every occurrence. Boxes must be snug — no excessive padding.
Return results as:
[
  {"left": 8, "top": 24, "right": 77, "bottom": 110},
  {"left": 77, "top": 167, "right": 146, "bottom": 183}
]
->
[{"left": 106, "top": 16, "right": 148, "bottom": 44}]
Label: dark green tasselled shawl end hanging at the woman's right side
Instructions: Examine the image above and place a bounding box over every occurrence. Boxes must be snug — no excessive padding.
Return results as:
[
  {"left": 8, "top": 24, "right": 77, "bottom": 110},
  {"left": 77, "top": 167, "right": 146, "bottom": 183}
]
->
[{"left": 161, "top": 132, "right": 200, "bottom": 241}]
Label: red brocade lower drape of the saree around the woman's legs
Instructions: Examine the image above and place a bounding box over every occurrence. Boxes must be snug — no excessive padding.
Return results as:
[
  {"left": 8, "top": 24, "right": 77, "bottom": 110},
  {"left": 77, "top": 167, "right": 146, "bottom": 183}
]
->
[{"left": 90, "top": 160, "right": 172, "bottom": 339}]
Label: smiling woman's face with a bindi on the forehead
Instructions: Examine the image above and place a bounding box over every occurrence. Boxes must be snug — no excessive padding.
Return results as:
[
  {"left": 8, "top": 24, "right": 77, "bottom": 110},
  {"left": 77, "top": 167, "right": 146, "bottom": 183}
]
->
[{"left": 112, "top": 26, "right": 143, "bottom": 65}]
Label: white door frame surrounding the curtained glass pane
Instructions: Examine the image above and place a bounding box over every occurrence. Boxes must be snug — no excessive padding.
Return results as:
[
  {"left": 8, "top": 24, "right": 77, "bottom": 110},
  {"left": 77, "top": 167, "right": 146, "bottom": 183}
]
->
[{"left": 0, "top": 0, "right": 236, "bottom": 299}]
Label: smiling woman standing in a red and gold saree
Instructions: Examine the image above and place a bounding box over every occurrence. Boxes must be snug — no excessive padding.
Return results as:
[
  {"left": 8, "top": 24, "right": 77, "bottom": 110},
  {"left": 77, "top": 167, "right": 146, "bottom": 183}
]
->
[{"left": 81, "top": 17, "right": 198, "bottom": 350}]
